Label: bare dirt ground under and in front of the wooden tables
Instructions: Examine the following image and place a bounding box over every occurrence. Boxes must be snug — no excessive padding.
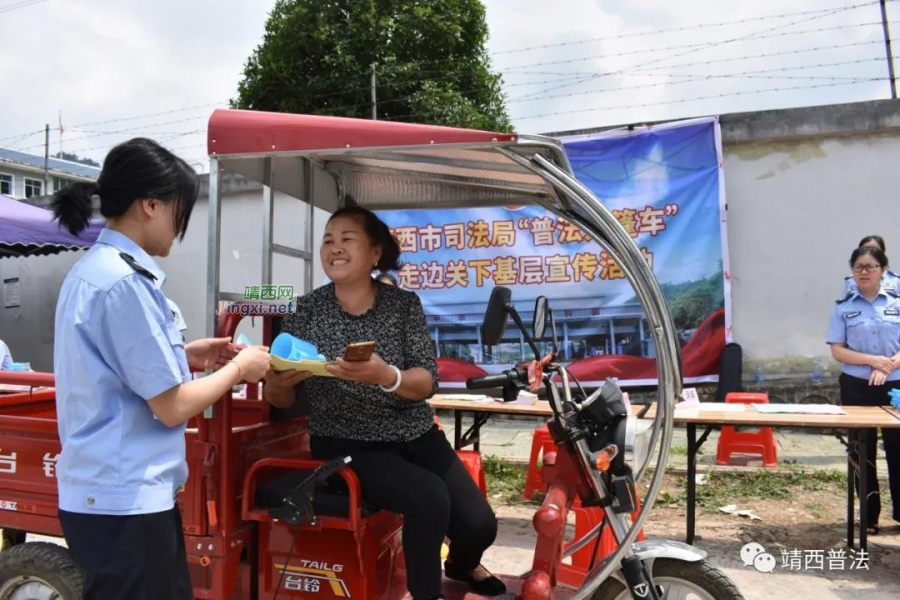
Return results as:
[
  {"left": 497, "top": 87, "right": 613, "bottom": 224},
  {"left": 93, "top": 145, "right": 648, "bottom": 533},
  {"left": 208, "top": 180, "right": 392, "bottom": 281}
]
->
[{"left": 485, "top": 478, "right": 900, "bottom": 600}]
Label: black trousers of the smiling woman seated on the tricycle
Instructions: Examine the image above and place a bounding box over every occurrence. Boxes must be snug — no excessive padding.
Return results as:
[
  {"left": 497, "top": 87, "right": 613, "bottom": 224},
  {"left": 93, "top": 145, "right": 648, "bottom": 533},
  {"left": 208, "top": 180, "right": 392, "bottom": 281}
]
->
[{"left": 310, "top": 427, "right": 497, "bottom": 600}]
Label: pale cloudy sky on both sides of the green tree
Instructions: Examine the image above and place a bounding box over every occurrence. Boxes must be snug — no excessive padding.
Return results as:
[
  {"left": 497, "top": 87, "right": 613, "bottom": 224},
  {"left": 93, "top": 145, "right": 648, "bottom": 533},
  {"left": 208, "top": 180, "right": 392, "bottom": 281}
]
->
[{"left": 0, "top": 0, "right": 900, "bottom": 172}]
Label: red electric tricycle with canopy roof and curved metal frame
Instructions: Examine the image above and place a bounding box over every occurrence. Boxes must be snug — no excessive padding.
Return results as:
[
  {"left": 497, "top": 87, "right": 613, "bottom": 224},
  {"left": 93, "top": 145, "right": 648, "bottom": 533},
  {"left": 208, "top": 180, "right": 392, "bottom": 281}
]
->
[{"left": 0, "top": 110, "right": 742, "bottom": 600}]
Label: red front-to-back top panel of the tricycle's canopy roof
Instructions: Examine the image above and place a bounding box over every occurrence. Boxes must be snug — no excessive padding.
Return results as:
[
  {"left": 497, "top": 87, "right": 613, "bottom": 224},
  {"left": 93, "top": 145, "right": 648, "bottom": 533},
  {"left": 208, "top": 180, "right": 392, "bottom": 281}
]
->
[{"left": 207, "top": 109, "right": 517, "bottom": 156}]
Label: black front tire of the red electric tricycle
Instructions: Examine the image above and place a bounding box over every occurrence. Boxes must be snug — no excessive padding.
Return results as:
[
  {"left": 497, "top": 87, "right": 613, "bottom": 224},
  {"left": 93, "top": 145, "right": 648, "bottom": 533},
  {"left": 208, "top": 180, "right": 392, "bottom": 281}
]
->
[{"left": 591, "top": 558, "right": 744, "bottom": 600}]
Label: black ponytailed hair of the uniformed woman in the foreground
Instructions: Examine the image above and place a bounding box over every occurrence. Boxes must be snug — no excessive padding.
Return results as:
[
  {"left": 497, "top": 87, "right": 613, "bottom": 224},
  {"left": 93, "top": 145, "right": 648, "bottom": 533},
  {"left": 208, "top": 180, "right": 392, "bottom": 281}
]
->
[{"left": 52, "top": 138, "right": 200, "bottom": 239}]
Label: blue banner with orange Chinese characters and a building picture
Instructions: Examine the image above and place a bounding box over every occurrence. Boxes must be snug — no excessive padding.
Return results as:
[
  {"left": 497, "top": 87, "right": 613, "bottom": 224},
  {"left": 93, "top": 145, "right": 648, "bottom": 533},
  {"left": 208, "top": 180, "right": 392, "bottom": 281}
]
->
[{"left": 379, "top": 118, "right": 730, "bottom": 387}]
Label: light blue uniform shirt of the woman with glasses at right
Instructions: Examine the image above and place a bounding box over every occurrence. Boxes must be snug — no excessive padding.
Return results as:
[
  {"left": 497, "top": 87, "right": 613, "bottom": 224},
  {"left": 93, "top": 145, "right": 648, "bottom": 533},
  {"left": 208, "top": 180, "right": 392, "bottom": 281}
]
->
[{"left": 826, "top": 286, "right": 900, "bottom": 381}]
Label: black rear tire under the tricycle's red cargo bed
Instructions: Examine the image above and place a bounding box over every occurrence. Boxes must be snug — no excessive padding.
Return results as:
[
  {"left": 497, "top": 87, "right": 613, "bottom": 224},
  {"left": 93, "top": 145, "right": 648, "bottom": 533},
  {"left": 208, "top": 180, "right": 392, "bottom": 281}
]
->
[{"left": 0, "top": 542, "right": 84, "bottom": 600}]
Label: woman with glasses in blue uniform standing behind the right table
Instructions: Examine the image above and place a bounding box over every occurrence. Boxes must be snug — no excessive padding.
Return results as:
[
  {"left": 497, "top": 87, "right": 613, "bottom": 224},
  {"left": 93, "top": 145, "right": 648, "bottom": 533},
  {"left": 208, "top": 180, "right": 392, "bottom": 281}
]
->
[{"left": 827, "top": 246, "right": 900, "bottom": 534}]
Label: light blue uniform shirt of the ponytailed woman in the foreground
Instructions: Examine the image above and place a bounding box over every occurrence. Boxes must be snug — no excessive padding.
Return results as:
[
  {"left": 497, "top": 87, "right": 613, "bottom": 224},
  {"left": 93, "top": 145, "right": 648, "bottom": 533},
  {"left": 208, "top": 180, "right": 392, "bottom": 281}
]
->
[{"left": 53, "top": 229, "right": 190, "bottom": 515}]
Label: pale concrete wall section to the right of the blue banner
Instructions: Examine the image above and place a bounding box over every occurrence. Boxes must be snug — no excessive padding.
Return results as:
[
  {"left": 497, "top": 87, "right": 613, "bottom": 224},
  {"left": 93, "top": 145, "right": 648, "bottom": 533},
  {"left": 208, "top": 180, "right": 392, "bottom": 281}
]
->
[{"left": 725, "top": 132, "right": 900, "bottom": 368}]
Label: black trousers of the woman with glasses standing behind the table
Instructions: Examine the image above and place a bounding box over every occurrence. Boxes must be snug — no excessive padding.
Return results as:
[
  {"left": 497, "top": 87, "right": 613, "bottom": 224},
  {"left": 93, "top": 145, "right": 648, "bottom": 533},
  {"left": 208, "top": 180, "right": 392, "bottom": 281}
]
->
[{"left": 839, "top": 373, "right": 900, "bottom": 526}]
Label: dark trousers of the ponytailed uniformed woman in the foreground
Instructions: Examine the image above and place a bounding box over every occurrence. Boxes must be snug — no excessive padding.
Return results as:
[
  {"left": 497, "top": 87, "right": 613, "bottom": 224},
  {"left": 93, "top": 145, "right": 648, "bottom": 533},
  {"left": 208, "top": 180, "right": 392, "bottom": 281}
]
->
[{"left": 59, "top": 506, "right": 194, "bottom": 600}]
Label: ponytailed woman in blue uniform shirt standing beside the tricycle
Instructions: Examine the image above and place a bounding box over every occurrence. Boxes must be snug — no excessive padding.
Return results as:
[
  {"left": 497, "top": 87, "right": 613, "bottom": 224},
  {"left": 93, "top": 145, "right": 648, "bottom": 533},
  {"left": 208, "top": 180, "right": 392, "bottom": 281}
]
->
[{"left": 53, "top": 138, "right": 270, "bottom": 600}]
